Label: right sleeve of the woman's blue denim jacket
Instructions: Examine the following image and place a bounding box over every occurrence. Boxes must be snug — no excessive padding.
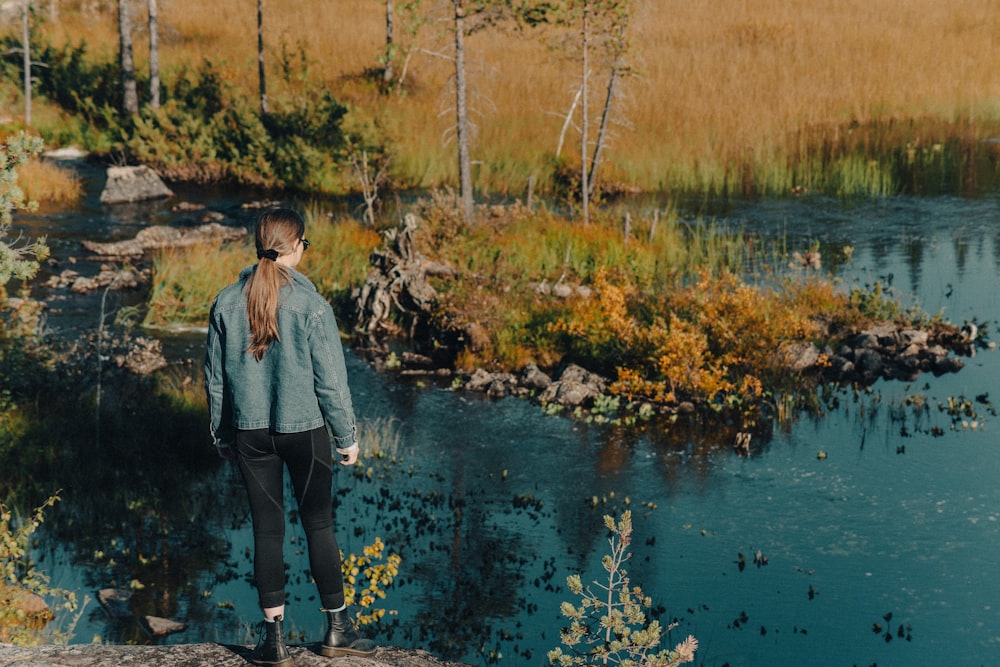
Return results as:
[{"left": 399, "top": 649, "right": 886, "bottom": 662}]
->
[{"left": 309, "top": 301, "right": 358, "bottom": 447}]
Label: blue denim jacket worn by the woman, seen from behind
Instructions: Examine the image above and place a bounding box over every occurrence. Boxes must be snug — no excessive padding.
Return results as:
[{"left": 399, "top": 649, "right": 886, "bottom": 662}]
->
[{"left": 205, "top": 265, "right": 358, "bottom": 447}]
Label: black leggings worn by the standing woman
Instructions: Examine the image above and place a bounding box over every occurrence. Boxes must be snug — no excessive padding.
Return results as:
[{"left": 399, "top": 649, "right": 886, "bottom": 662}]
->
[{"left": 236, "top": 427, "right": 344, "bottom": 609}]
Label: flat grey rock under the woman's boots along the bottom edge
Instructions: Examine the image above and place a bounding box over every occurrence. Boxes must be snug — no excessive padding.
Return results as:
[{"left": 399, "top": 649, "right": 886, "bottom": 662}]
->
[{"left": 0, "top": 643, "right": 468, "bottom": 667}]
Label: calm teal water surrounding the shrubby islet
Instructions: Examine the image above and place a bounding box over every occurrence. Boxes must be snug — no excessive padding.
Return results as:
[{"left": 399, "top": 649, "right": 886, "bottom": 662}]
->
[{"left": 9, "top": 179, "right": 1000, "bottom": 666}]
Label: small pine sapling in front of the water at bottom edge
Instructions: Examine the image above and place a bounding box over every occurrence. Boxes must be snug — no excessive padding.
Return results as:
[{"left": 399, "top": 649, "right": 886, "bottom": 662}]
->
[{"left": 548, "top": 510, "right": 698, "bottom": 667}]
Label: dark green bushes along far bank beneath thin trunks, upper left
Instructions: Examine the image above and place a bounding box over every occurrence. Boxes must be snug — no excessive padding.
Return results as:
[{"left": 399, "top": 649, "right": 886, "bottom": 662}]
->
[{"left": 0, "top": 36, "right": 364, "bottom": 191}]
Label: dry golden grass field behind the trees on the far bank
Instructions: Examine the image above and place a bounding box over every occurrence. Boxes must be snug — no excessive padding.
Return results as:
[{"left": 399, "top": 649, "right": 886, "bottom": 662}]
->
[{"left": 35, "top": 0, "right": 1000, "bottom": 191}]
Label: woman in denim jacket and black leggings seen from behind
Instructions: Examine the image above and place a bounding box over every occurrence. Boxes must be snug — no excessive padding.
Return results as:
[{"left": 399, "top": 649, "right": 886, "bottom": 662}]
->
[{"left": 205, "top": 209, "right": 375, "bottom": 665}]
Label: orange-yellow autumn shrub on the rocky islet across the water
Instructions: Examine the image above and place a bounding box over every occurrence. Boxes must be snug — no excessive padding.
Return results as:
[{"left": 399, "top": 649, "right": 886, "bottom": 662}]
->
[{"left": 550, "top": 270, "right": 859, "bottom": 416}]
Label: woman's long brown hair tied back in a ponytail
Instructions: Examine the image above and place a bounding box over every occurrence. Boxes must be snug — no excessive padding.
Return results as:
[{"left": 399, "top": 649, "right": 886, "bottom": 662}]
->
[{"left": 244, "top": 208, "right": 306, "bottom": 361}]
